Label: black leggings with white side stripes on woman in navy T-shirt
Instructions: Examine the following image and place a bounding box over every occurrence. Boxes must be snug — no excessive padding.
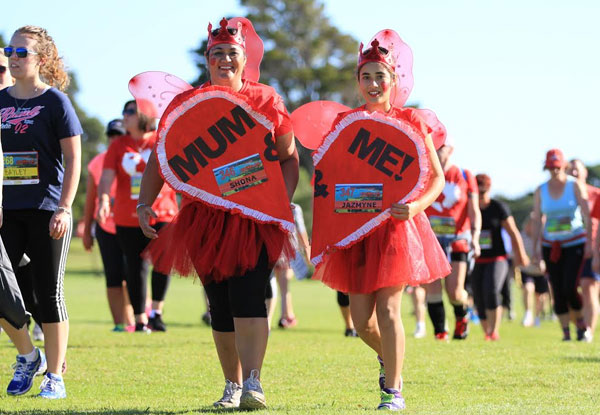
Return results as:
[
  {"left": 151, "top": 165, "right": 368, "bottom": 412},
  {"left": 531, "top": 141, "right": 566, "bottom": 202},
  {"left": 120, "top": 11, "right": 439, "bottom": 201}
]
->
[{"left": 0, "top": 209, "right": 73, "bottom": 323}]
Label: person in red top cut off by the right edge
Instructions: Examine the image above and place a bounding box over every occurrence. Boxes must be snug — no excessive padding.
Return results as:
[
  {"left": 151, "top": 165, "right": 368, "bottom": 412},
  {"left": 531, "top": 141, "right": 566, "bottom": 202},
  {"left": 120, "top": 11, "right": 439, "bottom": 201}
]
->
[{"left": 567, "top": 159, "right": 600, "bottom": 340}]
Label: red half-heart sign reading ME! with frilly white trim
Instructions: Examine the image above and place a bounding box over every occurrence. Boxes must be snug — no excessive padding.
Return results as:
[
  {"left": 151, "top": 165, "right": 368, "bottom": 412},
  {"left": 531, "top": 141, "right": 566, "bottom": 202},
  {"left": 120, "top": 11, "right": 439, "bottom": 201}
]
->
[{"left": 311, "top": 110, "right": 429, "bottom": 265}]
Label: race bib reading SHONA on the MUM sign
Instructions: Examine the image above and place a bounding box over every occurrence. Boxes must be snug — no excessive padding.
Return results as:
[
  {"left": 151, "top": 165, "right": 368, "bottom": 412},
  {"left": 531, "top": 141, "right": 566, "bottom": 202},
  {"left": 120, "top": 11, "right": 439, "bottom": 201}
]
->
[{"left": 213, "top": 153, "right": 267, "bottom": 197}]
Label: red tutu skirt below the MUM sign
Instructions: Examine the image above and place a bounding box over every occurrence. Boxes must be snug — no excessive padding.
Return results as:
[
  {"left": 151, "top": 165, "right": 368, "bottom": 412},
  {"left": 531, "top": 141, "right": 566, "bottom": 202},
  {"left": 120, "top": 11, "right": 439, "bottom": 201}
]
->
[{"left": 144, "top": 202, "right": 294, "bottom": 284}]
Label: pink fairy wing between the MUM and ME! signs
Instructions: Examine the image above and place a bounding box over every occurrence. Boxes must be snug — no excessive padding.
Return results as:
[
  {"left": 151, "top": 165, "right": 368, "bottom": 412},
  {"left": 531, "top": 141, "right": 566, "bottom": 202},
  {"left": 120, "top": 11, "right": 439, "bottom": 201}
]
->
[{"left": 291, "top": 101, "right": 350, "bottom": 150}]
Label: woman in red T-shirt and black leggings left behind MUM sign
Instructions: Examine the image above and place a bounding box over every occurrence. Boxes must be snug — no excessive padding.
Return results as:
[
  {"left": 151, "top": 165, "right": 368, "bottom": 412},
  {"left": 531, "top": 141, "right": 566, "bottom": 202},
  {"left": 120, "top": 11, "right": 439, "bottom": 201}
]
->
[{"left": 98, "top": 101, "right": 178, "bottom": 333}]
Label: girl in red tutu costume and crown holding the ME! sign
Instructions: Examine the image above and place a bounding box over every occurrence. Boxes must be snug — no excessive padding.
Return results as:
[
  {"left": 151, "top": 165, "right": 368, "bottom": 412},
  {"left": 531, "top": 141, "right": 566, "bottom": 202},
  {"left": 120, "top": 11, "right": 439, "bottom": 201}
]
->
[{"left": 313, "top": 30, "right": 450, "bottom": 410}]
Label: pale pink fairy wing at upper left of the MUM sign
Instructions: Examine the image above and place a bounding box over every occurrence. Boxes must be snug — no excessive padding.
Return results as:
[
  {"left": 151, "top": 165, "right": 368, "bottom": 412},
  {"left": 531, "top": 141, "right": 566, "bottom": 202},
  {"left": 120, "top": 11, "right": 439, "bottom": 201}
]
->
[{"left": 129, "top": 71, "right": 192, "bottom": 118}]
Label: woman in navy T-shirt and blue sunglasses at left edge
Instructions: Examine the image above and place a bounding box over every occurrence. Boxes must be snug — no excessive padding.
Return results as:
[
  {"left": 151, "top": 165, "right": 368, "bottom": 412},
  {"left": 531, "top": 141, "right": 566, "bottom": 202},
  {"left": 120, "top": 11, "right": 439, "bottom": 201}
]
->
[{"left": 0, "top": 26, "right": 82, "bottom": 399}]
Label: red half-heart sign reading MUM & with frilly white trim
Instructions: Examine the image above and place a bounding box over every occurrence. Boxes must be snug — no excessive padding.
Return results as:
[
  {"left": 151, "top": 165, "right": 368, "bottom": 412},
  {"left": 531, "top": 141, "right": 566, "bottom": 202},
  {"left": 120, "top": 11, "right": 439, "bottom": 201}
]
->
[{"left": 156, "top": 86, "right": 294, "bottom": 232}]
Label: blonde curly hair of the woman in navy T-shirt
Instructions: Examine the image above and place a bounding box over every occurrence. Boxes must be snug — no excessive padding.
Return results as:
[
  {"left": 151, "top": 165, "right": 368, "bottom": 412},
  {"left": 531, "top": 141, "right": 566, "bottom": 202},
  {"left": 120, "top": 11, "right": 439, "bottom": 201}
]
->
[{"left": 13, "top": 26, "right": 70, "bottom": 91}]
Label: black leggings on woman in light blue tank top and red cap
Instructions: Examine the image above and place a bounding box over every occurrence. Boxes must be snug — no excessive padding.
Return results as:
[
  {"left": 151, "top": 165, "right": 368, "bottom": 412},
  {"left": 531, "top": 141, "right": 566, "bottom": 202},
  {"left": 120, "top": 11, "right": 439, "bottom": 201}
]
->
[{"left": 542, "top": 244, "right": 585, "bottom": 315}]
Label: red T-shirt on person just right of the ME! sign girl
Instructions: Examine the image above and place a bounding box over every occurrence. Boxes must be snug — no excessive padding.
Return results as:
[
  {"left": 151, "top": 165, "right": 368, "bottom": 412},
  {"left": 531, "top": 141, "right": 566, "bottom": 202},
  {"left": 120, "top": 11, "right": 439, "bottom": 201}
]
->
[{"left": 425, "top": 165, "right": 479, "bottom": 237}]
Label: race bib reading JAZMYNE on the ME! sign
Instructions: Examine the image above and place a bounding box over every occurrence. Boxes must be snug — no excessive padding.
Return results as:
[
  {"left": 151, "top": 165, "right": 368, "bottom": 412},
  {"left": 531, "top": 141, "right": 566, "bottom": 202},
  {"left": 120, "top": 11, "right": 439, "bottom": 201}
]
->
[{"left": 335, "top": 184, "right": 383, "bottom": 213}]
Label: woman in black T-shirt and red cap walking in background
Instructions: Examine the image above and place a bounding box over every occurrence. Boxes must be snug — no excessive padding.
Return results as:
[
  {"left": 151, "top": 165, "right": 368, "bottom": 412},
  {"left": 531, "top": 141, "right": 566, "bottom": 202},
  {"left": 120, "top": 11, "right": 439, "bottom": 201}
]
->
[{"left": 471, "top": 174, "right": 529, "bottom": 341}]
